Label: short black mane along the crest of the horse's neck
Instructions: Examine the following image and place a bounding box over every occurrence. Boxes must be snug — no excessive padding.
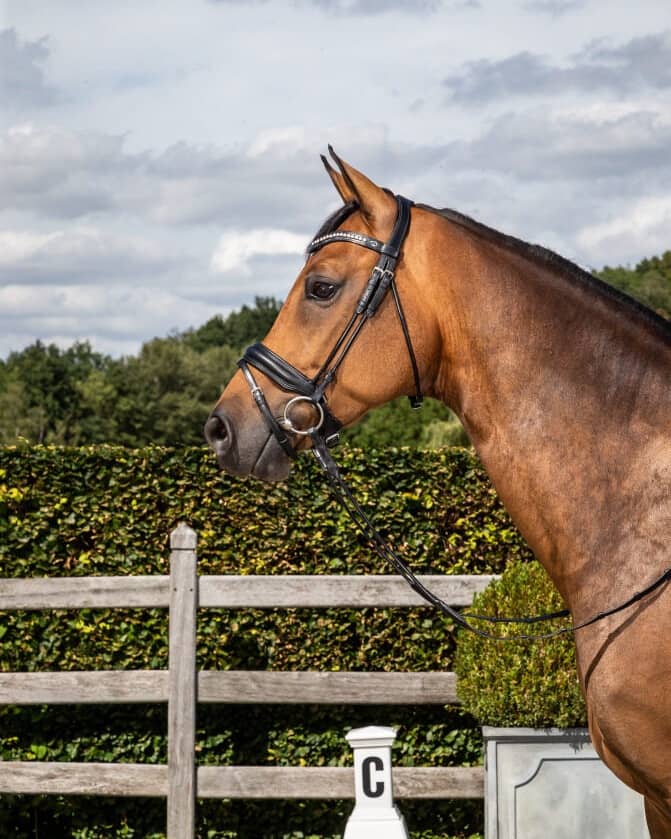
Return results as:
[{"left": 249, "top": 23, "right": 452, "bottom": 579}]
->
[{"left": 417, "top": 204, "right": 671, "bottom": 341}]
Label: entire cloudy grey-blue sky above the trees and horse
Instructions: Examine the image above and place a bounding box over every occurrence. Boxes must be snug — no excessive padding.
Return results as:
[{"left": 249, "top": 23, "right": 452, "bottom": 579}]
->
[{"left": 0, "top": 0, "right": 671, "bottom": 357}]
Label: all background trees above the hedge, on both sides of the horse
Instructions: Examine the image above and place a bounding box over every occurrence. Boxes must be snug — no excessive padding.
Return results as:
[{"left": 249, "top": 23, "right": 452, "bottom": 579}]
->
[{"left": 0, "top": 250, "right": 671, "bottom": 448}]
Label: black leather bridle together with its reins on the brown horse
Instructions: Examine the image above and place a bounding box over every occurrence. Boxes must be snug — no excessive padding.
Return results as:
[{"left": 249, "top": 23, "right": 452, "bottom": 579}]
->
[{"left": 238, "top": 195, "right": 671, "bottom": 641}]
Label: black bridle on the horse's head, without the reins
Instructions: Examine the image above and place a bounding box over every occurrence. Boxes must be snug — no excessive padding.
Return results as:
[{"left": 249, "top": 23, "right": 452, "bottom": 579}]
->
[{"left": 238, "top": 195, "right": 422, "bottom": 458}]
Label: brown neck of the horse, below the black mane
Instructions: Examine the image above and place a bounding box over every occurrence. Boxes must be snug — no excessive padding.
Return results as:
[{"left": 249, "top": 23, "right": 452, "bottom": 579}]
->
[{"left": 422, "top": 213, "right": 671, "bottom": 614}]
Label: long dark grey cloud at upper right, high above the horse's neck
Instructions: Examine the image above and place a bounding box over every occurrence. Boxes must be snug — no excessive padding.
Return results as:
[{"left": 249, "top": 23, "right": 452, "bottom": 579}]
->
[{"left": 443, "top": 32, "right": 671, "bottom": 105}]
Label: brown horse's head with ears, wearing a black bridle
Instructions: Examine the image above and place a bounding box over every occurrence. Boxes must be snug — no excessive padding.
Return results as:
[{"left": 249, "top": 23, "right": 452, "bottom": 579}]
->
[{"left": 205, "top": 149, "right": 438, "bottom": 480}]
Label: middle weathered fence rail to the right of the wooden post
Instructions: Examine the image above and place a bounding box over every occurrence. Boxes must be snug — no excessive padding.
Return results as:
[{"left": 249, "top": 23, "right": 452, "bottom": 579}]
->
[{"left": 198, "top": 670, "right": 458, "bottom": 705}]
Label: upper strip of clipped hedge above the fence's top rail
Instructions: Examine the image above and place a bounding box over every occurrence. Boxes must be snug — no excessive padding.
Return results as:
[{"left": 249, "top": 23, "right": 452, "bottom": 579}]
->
[{"left": 0, "top": 446, "right": 526, "bottom": 576}]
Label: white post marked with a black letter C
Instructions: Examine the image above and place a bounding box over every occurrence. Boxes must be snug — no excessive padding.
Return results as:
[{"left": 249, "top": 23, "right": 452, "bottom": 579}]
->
[{"left": 343, "top": 725, "right": 408, "bottom": 839}]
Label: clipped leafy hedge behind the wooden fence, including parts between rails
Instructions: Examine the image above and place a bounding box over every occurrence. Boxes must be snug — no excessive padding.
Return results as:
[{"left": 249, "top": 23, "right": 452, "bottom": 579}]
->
[{"left": 0, "top": 447, "right": 529, "bottom": 839}]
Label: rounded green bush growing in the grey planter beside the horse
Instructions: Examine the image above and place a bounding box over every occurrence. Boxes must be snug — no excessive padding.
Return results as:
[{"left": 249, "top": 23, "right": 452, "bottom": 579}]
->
[{"left": 454, "top": 561, "right": 587, "bottom": 728}]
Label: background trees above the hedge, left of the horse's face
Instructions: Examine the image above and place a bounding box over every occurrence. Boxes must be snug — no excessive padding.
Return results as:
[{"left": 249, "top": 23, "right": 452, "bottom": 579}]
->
[{"left": 0, "top": 297, "right": 280, "bottom": 446}]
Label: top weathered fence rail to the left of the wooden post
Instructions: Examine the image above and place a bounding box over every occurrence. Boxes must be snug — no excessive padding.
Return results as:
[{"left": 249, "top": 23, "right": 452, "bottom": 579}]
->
[{"left": 0, "top": 576, "right": 170, "bottom": 610}]
